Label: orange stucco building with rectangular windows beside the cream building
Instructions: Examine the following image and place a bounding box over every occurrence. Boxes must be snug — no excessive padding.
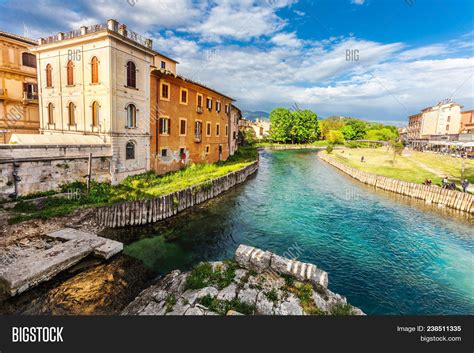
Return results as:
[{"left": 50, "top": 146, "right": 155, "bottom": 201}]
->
[{"left": 150, "top": 68, "right": 233, "bottom": 174}]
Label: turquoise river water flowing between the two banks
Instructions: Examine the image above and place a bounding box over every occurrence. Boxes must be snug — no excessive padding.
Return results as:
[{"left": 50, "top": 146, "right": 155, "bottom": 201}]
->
[{"left": 110, "top": 150, "right": 474, "bottom": 315}]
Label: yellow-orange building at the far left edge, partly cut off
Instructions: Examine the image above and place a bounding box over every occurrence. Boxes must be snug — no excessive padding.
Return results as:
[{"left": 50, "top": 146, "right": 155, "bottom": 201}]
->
[{"left": 0, "top": 31, "right": 39, "bottom": 143}]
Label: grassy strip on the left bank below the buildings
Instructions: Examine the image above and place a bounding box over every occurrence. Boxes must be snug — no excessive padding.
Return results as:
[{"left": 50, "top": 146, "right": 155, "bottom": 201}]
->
[{"left": 9, "top": 147, "right": 258, "bottom": 224}]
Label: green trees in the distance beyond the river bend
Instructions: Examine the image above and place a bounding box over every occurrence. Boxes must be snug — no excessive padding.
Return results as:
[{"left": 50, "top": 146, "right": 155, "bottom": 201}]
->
[{"left": 270, "top": 108, "right": 398, "bottom": 144}]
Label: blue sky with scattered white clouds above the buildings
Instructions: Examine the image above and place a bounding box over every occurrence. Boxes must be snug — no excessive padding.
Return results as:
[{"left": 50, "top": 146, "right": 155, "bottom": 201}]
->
[{"left": 0, "top": 0, "right": 474, "bottom": 126}]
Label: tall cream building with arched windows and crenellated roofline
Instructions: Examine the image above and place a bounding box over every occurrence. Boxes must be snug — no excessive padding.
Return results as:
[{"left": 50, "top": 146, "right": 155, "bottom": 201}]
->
[{"left": 28, "top": 20, "right": 172, "bottom": 183}]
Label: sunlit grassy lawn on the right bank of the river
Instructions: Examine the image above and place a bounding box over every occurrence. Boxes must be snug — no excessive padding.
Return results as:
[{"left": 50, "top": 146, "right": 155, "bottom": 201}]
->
[{"left": 323, "top": 147, "right": 474, "bottom": 185}]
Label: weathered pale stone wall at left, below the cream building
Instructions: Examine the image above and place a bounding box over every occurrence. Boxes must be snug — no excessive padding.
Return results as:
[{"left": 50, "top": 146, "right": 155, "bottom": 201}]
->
[{"left": 0, "top": 145, "right": 111, "bottom": 199}]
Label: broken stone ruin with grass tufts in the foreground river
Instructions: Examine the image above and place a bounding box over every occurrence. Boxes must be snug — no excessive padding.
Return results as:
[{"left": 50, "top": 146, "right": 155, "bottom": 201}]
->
[{"left": 122, "top": 245, "right": 364, "bottom": 315}]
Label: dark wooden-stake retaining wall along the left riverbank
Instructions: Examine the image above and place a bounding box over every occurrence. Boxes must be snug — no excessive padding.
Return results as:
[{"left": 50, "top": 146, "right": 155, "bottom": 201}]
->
[{"left": 96, "top": 161, "right": 258, "bottom": 228}]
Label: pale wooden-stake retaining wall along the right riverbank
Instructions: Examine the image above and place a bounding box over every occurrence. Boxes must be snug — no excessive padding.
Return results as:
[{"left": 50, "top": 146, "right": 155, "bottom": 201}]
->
[{"left": 319, "top": 153, "right": 474, "bottom": 213}]
